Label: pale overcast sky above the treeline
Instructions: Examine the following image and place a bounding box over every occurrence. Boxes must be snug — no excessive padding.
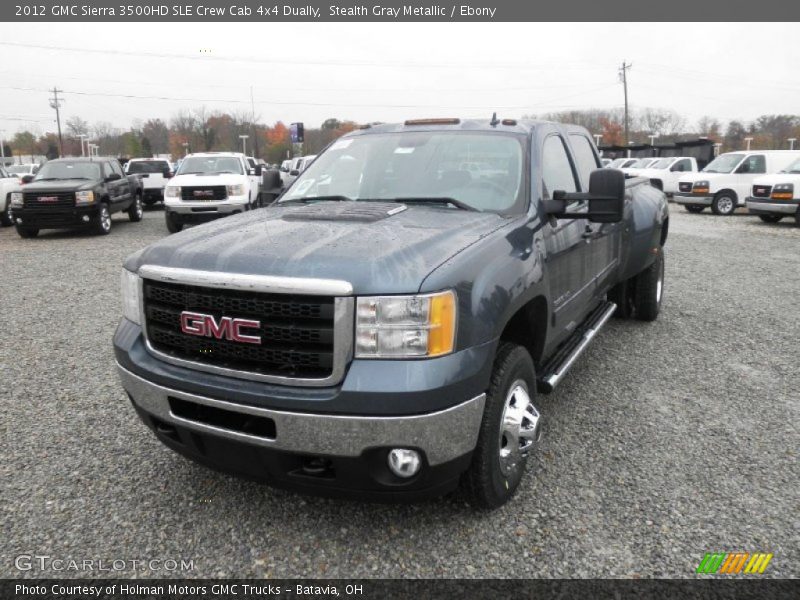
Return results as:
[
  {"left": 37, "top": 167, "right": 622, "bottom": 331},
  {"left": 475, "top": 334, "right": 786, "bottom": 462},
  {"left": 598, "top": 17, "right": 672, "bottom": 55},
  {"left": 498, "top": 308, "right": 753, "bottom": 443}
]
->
[{"left": 0, "top": 23, "right": 800, "bottom": 137}]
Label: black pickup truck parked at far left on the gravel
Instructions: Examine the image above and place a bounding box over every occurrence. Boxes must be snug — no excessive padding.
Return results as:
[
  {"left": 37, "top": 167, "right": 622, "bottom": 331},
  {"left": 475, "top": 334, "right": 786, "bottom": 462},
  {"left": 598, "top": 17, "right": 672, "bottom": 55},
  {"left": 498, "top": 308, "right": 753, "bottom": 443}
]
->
[{"left": 11, "top": 156, "right": 142, "bottom": 238}]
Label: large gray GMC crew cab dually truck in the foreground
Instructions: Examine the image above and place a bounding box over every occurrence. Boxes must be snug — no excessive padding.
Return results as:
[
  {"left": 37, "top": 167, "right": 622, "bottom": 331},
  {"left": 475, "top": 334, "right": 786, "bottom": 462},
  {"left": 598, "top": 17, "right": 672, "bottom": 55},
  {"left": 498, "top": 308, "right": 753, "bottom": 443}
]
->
[{"left": 114, "top": 118, "right": 669, "bottom": 508}]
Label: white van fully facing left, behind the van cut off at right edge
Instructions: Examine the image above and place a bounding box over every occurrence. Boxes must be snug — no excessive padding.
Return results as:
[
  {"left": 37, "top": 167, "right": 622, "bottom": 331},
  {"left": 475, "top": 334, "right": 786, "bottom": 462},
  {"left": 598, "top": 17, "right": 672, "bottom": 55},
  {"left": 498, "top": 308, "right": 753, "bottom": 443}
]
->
[{"left": 674, "top": 150, "right": 800, "bottom": 215}]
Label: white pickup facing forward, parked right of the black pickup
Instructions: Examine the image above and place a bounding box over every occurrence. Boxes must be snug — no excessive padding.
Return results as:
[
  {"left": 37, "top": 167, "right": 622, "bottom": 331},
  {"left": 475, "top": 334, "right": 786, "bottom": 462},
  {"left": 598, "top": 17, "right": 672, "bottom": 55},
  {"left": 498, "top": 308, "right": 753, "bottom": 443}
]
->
[{"left": 164, "top": 152, "right": 261, "bottom": 233}]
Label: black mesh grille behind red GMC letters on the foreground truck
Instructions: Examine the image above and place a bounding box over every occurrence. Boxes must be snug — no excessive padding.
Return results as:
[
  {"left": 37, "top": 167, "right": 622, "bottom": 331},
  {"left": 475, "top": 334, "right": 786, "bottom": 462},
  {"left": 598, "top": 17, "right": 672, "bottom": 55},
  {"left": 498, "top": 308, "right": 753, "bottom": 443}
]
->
[{"left": 144, "top": 280, "right": 334, "bottom": 379}]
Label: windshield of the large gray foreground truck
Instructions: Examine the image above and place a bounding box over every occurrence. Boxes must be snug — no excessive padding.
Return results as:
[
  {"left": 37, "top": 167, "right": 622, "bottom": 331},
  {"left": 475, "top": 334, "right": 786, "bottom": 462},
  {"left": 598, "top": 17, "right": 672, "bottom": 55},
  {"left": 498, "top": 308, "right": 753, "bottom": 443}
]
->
[{"left": 281, "top": 132, "right": 524, "bottom": 212}]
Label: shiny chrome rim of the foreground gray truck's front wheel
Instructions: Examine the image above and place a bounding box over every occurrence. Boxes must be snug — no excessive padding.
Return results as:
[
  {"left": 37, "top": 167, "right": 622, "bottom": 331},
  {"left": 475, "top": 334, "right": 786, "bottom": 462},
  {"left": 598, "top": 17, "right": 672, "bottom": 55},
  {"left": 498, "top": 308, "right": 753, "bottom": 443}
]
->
[{"left": 498, "top": 379, "right": 539, "bottom": 476}]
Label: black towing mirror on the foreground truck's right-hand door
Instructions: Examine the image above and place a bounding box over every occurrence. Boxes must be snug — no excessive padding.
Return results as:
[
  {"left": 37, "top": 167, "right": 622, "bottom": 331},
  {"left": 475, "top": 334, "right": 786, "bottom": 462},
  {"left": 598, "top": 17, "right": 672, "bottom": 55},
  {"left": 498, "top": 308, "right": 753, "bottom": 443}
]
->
[{"left": 544, "top": 169, "right": 625, "bottom": 223}]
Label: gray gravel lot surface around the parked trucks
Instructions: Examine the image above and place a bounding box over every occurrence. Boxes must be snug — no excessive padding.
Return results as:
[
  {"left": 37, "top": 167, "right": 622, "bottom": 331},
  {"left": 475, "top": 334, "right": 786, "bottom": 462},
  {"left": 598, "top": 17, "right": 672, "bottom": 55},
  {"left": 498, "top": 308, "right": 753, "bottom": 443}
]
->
[{"left": 0, "top": 205, "right": 800, "bottom": 577}]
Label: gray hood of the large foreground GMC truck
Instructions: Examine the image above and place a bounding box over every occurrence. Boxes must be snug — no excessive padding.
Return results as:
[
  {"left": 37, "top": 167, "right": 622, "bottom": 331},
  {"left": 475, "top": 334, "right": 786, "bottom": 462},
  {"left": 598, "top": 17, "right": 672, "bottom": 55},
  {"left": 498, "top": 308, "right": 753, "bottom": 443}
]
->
[{"left": 125, "top": 202, "right": 509, "bottom": 294}]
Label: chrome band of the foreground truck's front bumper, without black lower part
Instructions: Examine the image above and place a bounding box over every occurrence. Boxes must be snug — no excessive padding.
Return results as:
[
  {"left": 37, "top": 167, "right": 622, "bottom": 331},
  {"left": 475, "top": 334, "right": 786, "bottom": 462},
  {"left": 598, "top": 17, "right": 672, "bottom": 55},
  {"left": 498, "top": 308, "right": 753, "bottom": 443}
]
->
[{"left": 117, "top": 363, "right": 486, "bottom": 466}]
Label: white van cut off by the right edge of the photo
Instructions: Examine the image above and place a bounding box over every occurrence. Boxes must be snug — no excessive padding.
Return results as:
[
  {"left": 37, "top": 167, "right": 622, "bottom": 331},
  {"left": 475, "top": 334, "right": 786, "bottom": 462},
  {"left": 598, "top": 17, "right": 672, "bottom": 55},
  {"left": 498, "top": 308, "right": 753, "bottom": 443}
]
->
[{"left": 746, "top": 159, "right": 800, "bottom": 227}]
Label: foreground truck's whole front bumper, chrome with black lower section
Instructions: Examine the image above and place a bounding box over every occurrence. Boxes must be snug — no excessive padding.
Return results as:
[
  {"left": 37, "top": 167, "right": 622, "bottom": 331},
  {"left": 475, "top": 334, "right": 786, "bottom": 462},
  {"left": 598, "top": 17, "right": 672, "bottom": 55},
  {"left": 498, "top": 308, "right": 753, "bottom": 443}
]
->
[{"left": 117, "top": 364, "right": 485, "bottom": 500}]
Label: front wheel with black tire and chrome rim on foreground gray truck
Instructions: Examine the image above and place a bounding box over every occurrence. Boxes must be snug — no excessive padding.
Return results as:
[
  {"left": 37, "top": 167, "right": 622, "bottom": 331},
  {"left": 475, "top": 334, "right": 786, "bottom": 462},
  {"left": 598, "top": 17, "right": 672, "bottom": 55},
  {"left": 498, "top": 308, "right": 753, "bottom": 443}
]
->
[{"left": 462, "top": 342, "right": 540, "bottom": 509}]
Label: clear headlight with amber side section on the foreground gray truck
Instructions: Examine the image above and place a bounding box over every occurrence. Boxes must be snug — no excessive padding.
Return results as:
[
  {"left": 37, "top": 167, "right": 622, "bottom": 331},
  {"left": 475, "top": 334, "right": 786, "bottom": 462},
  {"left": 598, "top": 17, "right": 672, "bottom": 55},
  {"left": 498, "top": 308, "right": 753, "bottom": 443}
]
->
[{"left": 356, "top": 291, "right": 456, "bottom": 358}]
